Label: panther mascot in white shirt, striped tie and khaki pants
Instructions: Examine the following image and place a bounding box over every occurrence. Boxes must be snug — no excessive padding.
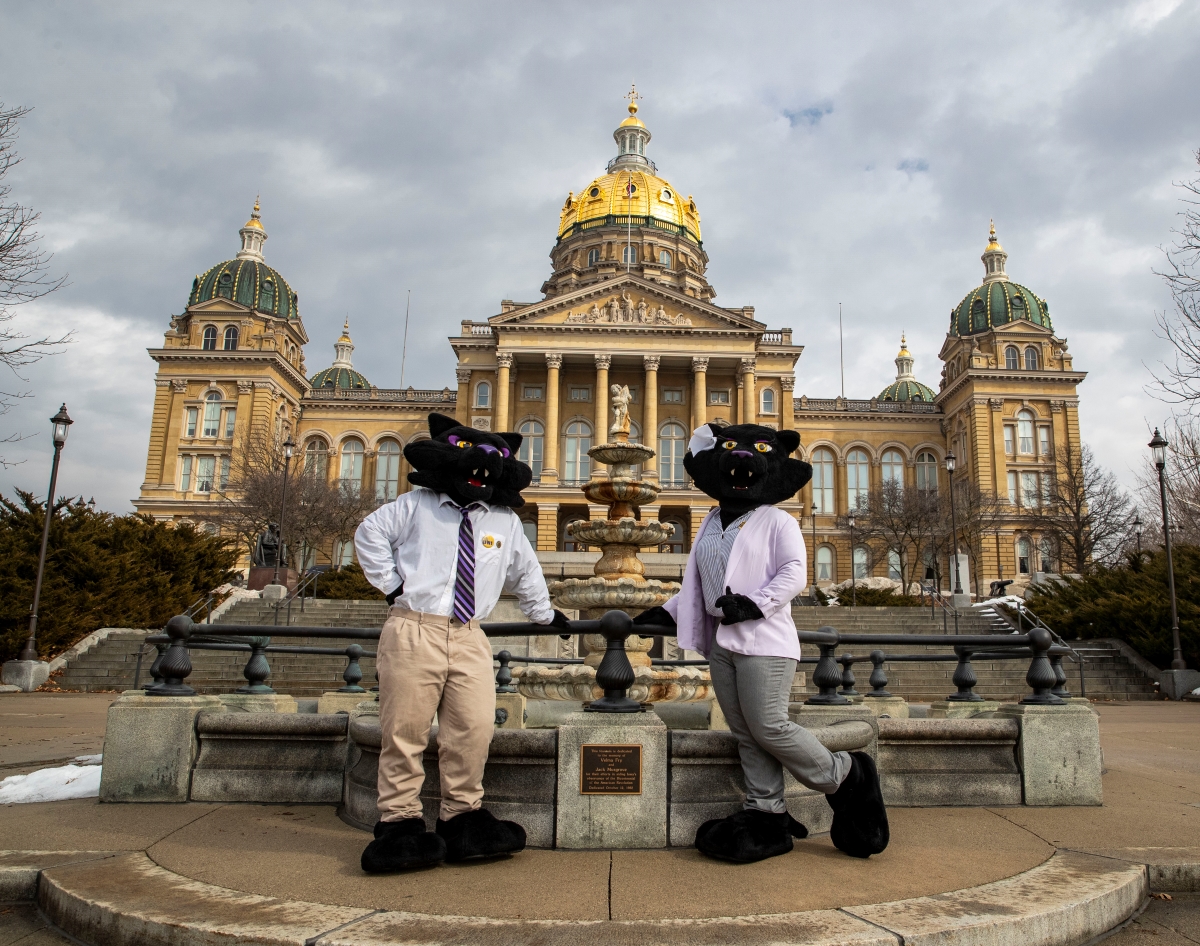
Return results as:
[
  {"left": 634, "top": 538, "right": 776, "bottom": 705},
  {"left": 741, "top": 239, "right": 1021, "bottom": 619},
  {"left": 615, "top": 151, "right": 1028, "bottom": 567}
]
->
[{"left": 354, "top": 413, "right": 569, "bottom": 873}]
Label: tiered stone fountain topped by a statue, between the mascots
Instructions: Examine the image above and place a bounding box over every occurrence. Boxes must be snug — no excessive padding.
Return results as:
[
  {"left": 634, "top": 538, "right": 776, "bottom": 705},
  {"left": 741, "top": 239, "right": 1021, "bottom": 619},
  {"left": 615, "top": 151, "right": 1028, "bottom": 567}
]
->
[{"left": 512, "top": 384, "right": 712, "bottom": 703}]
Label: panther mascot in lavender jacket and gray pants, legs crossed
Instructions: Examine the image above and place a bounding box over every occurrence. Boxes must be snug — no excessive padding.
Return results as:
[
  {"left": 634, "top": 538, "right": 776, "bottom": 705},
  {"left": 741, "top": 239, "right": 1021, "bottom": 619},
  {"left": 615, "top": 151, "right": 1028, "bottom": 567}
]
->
[{"left": 634, "top": 424, "right": 888, "bottom": 863}]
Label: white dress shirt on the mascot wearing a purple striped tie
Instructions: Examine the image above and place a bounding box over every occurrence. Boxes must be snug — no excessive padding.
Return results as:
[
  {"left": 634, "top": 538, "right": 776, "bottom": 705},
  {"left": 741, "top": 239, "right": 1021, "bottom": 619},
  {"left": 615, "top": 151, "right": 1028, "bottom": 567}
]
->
[{"left": 354, "top": 486, "right": 554, "bottom": 624}]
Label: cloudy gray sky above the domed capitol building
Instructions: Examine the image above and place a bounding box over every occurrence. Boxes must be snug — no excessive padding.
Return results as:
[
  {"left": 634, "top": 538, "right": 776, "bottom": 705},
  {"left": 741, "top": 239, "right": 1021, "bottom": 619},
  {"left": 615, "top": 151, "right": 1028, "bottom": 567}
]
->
[{"left": 0, "top": 0, "right": 1200, "bottom": 511}]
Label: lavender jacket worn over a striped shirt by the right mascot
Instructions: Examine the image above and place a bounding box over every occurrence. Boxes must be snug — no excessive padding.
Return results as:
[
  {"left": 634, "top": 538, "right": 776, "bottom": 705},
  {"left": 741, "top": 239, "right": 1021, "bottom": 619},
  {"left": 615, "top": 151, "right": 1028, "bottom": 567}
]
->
[{"left": 664, "top": 505, "right": 808, "bottom": 660}]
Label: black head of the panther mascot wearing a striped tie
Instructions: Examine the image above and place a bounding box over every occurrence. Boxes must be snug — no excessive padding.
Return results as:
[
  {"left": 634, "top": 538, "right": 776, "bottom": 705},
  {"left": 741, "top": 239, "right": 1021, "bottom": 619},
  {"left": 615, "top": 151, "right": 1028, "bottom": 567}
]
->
[{"left": 404, "top": 413, "right": 533, "bottom": 509}]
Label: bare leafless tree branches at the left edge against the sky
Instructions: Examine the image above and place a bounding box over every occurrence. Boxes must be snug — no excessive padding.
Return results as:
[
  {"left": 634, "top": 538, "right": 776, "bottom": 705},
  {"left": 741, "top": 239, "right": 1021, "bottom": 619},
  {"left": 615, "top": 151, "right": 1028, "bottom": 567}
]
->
[{"left": 0, "top": 102, "right": 71, "bottom": 467}]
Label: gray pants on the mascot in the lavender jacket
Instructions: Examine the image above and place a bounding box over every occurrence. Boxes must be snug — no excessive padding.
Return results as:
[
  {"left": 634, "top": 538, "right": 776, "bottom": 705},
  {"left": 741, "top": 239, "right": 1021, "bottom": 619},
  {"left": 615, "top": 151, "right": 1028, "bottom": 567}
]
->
[{"left": 709, "top": 642, "right": 850, "bottom": 814}]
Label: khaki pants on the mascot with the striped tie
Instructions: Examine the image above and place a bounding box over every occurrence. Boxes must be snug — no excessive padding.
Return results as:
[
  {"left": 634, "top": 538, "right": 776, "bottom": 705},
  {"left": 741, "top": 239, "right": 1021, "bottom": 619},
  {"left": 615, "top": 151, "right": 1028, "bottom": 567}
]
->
[{"left": 376, "top": 607, "right": 496, "bottom": 821}]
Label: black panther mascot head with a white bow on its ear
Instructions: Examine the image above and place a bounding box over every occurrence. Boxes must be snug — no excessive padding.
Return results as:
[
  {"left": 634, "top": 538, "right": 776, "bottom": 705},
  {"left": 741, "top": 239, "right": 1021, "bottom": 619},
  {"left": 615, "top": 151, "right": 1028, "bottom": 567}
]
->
[{"left": 683, "top": 424, "right": 812, "bottom": 509}]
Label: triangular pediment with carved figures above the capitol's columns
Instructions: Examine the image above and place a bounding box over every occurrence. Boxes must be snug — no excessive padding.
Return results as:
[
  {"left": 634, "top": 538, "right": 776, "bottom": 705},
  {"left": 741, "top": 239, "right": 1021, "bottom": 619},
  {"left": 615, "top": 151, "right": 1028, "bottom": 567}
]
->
[{"left": 488, "top": 276, "right": 763, "bottom": 331}]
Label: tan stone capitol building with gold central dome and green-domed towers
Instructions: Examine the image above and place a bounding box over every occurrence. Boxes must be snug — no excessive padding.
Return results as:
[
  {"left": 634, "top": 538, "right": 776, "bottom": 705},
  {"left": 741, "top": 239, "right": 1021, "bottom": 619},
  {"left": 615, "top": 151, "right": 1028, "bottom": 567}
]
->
[{"left": 133, "top": 101, "right": 1085, "bottom": 588}]
